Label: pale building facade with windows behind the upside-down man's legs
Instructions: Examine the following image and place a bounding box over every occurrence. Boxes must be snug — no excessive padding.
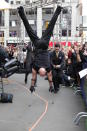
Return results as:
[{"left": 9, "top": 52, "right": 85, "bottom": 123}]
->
[{"left": 0, "top": 0, "right": 81, "bottom": 46}]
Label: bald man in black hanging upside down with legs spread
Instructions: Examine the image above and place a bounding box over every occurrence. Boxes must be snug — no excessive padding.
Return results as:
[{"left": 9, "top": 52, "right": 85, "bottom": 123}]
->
[{"left": 18, "top": 6, "right": 62, "bottom": 92}]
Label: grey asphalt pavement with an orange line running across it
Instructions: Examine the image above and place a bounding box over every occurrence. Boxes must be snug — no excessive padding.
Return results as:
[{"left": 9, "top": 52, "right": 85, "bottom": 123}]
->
[{"left": 0, "top": 74, "right": 87, "bottom": 131}]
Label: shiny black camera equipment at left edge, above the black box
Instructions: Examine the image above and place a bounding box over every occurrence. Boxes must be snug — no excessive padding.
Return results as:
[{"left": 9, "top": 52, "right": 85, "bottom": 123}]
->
[{"left": 0, "top": 46, "right": 19, "bottom": 78}]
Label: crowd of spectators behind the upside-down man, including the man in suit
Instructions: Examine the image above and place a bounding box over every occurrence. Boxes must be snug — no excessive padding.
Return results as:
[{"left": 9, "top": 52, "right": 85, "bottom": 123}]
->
[{"left": 0, "top": 39, "right": 87, "bottom": 93}]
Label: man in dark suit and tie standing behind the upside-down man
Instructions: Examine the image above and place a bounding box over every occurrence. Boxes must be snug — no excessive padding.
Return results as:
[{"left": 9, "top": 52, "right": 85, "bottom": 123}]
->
[{"left": 51, "top": 43, "right": 65, "bottom": 93}]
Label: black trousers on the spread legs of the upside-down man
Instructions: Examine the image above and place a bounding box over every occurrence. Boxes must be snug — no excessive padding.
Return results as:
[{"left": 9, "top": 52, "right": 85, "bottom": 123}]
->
[{"left": 18, "top": 6, "right": 61, "bottom": 48}]
